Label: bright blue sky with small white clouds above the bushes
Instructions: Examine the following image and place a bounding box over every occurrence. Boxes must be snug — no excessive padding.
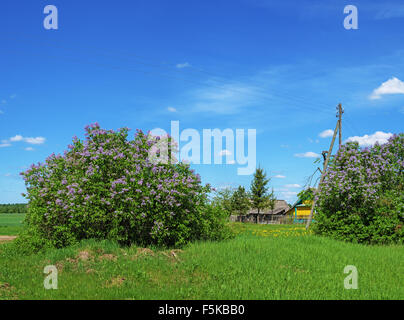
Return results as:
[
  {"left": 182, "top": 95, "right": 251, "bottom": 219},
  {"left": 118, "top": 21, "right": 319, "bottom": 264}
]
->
[{"left": 0, "top": 0, "right": 404, "bottom": 203}]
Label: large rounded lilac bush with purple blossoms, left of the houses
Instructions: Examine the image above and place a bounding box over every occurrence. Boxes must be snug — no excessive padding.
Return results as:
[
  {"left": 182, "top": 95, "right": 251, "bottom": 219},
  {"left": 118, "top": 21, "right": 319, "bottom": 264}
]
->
[{"left": 21, "top": 124, "right": 230, "bottom": 247}]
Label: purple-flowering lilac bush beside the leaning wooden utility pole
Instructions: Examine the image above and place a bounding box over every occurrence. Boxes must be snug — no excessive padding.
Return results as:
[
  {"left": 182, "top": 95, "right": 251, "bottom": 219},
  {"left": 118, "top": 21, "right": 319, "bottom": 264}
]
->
[{"left": 313, "top": 134, "right": 404, "bottom": 244}]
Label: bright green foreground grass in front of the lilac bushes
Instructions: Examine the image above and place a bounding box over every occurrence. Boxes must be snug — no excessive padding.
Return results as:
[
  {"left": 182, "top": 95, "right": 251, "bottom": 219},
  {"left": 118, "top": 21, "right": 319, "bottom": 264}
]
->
[{"left": 0, "top": 224, "right": 404, "bottom": 299}]
